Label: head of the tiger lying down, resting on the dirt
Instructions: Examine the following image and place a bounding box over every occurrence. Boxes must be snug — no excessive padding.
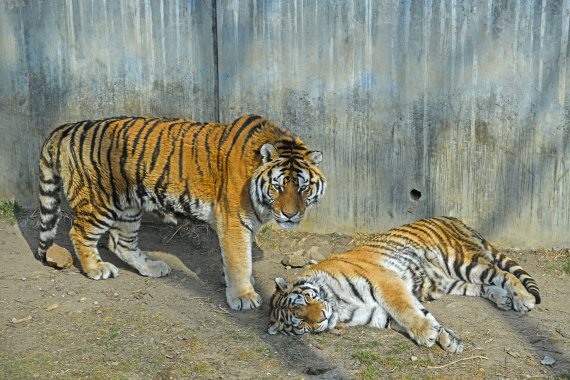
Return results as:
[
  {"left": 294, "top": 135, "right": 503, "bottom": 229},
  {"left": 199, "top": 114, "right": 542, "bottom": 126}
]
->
[{"left": 267, "top": 277, "right": 332, "bottom": 335}]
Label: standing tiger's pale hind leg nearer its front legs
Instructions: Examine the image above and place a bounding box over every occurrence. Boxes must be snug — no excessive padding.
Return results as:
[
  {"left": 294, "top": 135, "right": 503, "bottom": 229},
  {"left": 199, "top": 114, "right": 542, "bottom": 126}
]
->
[{"left": 109, "top": 209, "right": 170, "bottom": 277}]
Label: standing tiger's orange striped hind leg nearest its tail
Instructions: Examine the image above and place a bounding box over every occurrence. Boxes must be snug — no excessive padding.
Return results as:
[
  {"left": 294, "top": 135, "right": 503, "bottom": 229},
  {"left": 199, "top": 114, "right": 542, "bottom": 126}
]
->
[{"left": 69, "top": 216, "right": 119, "bottom": 280}]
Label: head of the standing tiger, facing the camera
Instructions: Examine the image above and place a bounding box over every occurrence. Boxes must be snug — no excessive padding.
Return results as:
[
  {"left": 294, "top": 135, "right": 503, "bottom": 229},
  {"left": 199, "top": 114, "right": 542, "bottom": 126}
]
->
[{"left": 251, "top": 137, "right": 326, "bottom": 228}]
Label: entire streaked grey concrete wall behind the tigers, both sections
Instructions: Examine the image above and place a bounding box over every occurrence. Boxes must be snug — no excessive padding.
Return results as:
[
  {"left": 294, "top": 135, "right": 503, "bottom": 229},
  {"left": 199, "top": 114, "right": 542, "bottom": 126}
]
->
[{"left": 0, "top": 0, "right": 570, "bottom": 247}]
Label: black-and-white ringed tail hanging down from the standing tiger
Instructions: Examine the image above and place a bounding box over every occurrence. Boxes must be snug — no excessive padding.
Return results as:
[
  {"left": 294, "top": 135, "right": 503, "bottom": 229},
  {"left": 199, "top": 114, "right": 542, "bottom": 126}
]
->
[{"left": 35, "top": 135, "right": 61, "bottom": 261}]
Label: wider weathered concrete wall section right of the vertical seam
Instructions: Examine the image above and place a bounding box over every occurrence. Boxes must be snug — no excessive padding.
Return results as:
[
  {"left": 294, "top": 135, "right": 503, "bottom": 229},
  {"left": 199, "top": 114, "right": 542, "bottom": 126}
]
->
[{"left": 218, "top": 0, "right": 570, "bottom": 246}]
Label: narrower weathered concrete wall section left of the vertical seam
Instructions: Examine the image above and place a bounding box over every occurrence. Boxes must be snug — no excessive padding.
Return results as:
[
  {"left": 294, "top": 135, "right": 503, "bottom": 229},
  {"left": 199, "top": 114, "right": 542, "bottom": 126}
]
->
[{"left": 0, "top": 0, "right": 218, "bottom": 207}]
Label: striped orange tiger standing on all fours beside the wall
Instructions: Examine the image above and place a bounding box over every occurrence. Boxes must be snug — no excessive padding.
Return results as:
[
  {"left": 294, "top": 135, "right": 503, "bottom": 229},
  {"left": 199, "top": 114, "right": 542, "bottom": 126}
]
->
[{"left": 36, "top": 115, "right": 326, "bottom": 310}]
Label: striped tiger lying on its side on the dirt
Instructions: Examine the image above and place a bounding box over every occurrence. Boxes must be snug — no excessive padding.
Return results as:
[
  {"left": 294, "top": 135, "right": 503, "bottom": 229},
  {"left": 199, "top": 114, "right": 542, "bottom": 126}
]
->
[{"left": 268, "top": 217, "right": 540, "bottom": 353}]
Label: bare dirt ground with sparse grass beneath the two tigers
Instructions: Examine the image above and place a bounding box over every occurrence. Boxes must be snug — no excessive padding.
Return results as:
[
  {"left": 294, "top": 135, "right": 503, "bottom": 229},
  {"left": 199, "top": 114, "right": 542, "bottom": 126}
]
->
[{"left": 0, "top": 215, "right": 570, "bottom": 379}]
